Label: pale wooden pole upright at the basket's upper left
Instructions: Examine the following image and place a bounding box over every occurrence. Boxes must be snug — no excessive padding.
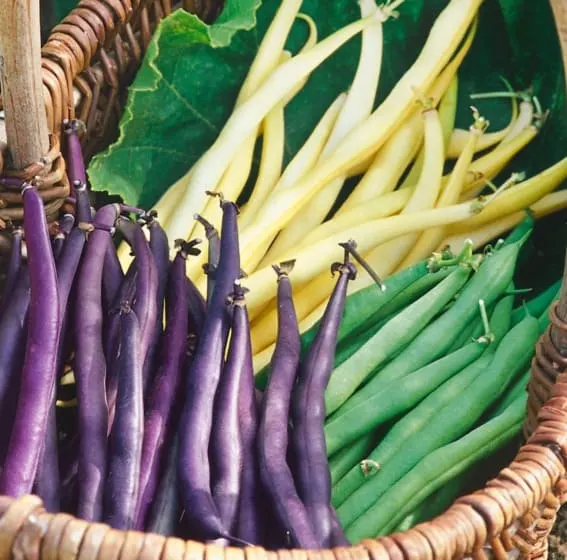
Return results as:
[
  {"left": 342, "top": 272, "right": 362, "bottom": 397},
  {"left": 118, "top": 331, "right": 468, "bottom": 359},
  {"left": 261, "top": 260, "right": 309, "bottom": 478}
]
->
[{"left": 0, "top": 0, "right": 49, "bottom": 169}]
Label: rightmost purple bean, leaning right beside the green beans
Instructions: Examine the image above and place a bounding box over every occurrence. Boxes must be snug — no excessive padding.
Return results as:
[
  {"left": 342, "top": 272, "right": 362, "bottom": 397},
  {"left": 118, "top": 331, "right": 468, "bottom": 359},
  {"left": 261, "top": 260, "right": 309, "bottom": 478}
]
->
[{"left": 291, "top": 251, "right": 356, "bottom": 548}]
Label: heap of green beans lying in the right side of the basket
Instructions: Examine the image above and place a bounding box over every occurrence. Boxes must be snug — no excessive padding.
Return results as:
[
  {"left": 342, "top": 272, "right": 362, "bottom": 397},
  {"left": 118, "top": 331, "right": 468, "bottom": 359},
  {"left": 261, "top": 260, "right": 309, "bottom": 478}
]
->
[{"left": 318, "top": 224, "right": 560, "bottom": 542}]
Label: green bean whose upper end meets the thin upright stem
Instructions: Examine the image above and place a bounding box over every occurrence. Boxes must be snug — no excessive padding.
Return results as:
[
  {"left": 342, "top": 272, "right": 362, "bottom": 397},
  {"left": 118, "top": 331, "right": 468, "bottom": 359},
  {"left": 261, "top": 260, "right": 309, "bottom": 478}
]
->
[{"left": 325, "top": 336, "right": 486, "bottom": 454}]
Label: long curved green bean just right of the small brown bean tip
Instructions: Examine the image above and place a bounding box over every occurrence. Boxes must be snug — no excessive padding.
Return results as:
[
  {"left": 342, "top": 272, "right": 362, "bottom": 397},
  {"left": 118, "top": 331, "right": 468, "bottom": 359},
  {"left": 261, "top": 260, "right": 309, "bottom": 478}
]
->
[{"left": 338, "top": 317, "right": 539, "bottom": 527}]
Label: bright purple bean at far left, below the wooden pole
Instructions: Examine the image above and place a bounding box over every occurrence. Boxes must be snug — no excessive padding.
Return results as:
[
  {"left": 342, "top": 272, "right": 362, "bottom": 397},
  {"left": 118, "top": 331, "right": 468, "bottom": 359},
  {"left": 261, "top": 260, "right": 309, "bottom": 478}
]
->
[{"left": 0, "top": 185, "right": 60, "bottom": 497}]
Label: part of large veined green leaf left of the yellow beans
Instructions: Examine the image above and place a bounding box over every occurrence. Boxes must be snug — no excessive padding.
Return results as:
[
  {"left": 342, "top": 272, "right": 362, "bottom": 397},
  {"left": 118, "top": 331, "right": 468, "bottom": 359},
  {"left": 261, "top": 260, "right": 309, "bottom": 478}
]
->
[{"left": 89, "top": 0, "right": 259, "bottom": 206}]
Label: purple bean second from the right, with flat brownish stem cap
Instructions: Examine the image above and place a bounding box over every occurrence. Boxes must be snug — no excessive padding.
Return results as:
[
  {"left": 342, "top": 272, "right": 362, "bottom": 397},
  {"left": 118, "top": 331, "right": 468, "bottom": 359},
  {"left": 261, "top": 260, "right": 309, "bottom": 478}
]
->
[{"left": 258, "top": 262, "right": 320, "bottom": 549}]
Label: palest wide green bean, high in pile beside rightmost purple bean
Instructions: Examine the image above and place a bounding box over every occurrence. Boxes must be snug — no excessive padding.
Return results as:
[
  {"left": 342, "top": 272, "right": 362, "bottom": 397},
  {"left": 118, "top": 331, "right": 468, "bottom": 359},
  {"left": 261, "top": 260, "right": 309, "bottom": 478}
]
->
[{"left": 325, "top": 267, "right": 469, "bottom": 415}]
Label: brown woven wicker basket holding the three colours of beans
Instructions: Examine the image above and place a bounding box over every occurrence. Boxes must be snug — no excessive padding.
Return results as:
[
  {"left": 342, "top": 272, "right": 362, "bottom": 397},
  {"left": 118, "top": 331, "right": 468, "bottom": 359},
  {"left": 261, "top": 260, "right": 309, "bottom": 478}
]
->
[{"left": 0, "top": 0, "right": 567, "bottom": 560}]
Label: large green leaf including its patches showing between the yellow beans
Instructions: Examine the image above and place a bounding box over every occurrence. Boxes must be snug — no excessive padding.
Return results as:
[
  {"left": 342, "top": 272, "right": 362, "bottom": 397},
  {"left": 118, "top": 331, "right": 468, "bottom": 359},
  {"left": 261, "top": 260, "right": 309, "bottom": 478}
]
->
[{"left": 89, "top": 0, "right": 446, "bottom": 206}]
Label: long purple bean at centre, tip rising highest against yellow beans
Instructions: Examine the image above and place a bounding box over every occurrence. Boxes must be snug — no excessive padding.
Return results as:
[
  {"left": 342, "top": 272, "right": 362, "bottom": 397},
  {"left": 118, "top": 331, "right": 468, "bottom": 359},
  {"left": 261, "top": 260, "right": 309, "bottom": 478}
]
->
[{"left": 178, "top": 196, "right": 240, "bottom": 539}]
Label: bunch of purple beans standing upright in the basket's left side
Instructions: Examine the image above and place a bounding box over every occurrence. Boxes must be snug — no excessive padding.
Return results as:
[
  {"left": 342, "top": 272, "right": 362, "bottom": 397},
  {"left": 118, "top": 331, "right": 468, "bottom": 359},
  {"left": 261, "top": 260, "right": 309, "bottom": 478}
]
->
[{"left": 0, "top": 122, "right": 356, "bottom": 549}]
